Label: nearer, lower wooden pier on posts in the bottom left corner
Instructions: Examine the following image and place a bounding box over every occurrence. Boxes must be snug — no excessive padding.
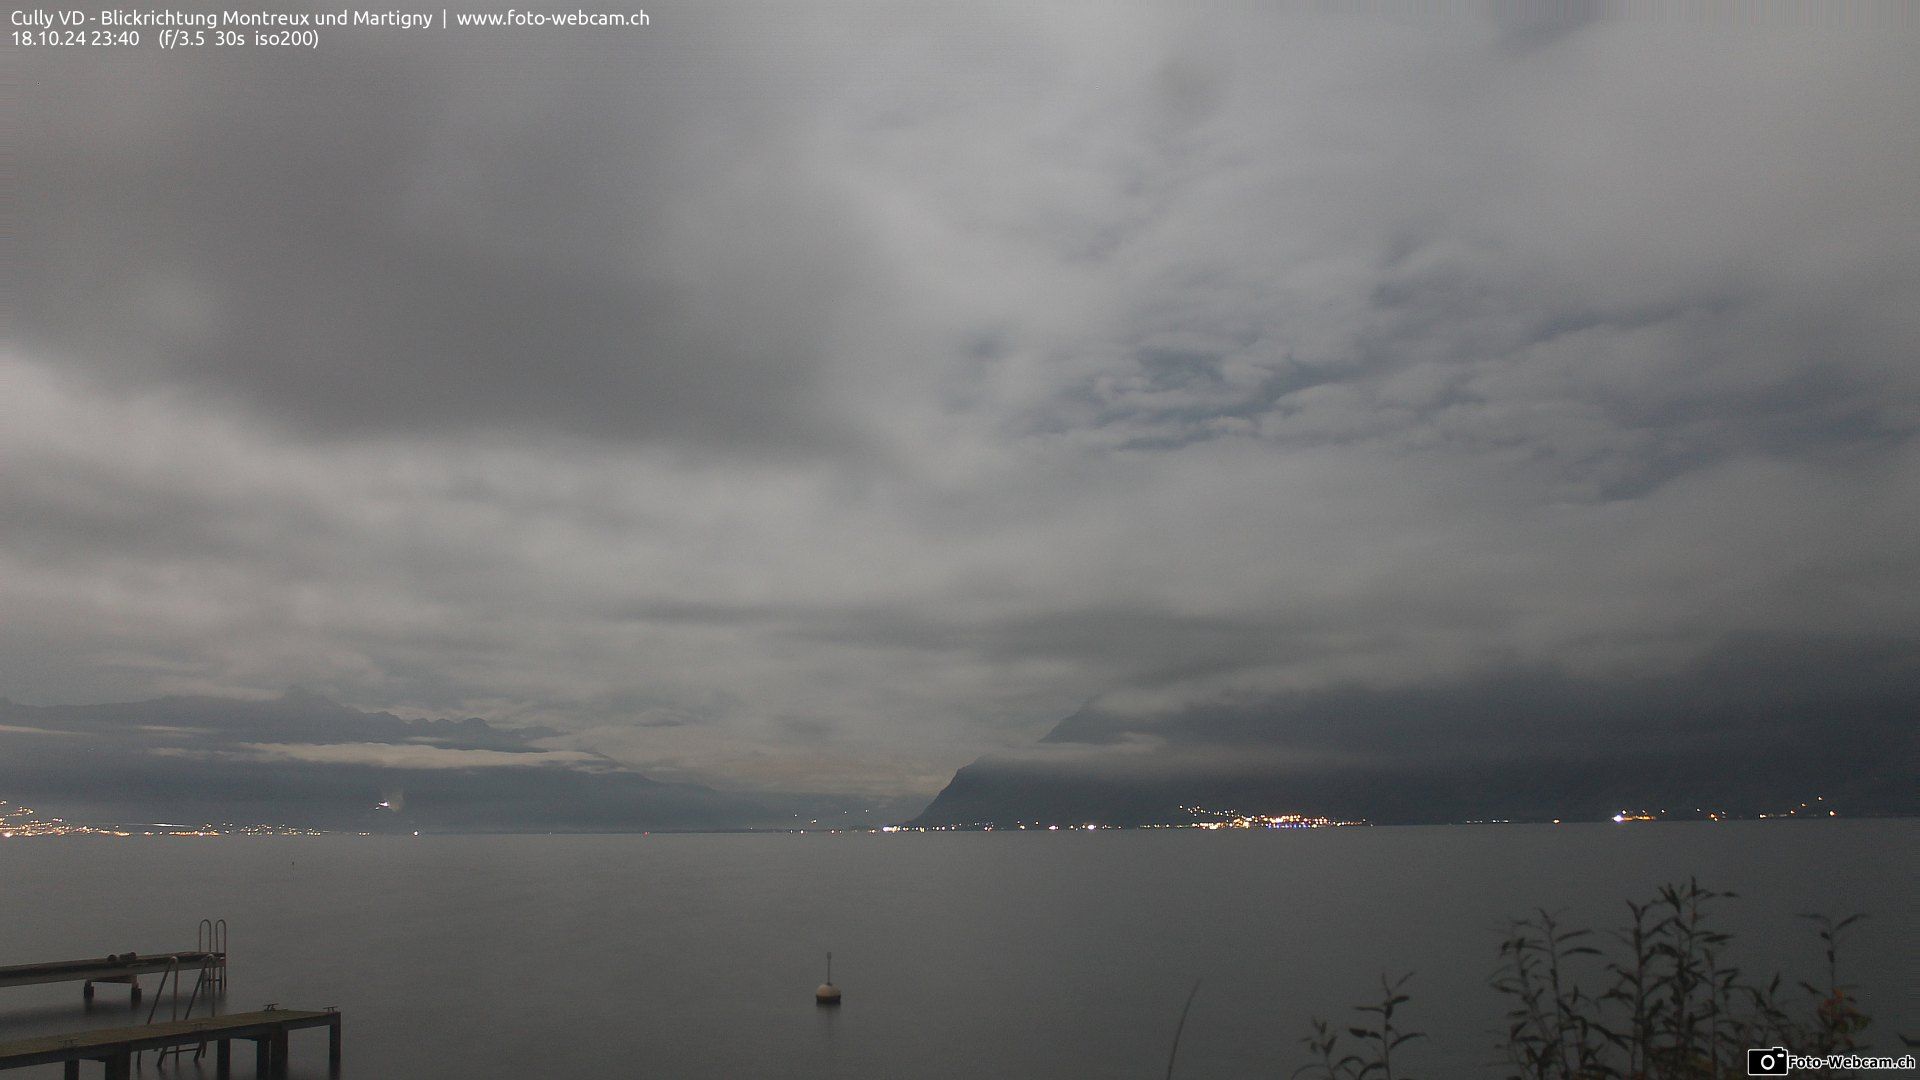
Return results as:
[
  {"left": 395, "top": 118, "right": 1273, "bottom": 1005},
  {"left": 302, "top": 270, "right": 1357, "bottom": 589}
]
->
[{"left": 0, "top": 1009, "right": 340, "bottom": 1080}]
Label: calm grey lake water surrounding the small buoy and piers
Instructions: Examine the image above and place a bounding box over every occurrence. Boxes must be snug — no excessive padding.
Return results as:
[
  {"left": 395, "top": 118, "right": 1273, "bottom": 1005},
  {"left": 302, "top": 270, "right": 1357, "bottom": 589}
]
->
[{"left": 0, "top": 821, "right": 1920, "bottom": 1080}]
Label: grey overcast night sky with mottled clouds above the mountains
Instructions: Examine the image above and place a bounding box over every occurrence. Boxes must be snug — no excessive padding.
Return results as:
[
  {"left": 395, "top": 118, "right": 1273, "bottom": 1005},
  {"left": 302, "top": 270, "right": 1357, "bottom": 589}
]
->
[{"left": 0, "top": 2, "right": 1920, "bottom": 796}]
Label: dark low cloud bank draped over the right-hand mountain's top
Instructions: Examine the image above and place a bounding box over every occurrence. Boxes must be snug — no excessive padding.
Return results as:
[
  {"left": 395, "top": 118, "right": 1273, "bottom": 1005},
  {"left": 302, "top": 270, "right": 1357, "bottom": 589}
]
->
[{"left": 1043, "top": 638, "right": 1920, "bottom": 760}]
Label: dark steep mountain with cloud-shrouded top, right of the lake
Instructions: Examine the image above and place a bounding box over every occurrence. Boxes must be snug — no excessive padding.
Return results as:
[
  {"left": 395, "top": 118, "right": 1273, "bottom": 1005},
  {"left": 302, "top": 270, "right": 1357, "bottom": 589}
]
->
[{"left": 916, "top": 640, "right": 1920, "bottom": 824}]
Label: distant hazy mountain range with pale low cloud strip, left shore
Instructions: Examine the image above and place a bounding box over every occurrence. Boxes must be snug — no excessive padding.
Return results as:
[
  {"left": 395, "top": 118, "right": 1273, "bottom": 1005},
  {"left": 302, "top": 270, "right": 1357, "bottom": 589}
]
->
[{"left": 0, "top": 688, "right": 818, "bottom": 830}]
